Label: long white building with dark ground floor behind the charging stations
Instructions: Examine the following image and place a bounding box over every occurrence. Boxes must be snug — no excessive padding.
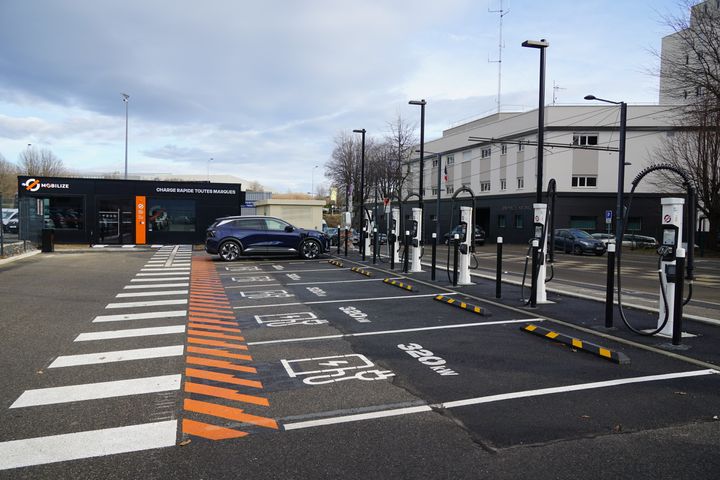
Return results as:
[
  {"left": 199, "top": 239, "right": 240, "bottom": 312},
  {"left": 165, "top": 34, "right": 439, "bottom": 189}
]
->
[{"left": 403, "top": 102, "right": 674, "bottom": 243}]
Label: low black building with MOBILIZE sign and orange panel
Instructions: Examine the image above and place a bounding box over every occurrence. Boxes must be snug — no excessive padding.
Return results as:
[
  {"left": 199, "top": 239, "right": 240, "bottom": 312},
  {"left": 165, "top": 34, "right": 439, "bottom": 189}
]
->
[{"left": 18, "top": 176, "right": 245, "bottom": 245}]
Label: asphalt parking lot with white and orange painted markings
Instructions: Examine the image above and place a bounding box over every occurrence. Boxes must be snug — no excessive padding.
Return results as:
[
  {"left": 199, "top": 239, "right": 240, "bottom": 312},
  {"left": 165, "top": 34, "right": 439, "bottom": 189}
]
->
[{"left": 0, "top": 246, "right": 720, "bottom": 478}]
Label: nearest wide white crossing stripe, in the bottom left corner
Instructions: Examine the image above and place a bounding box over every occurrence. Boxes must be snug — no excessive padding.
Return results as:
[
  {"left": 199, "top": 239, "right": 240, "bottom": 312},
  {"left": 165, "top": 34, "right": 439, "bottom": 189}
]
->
[{"left": 0, "top": 420, "right": 177, "bottom": 470}]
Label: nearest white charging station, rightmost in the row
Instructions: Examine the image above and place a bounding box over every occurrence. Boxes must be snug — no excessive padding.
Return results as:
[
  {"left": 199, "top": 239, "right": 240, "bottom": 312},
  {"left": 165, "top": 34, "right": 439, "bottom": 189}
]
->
[{"left": 657, "top": 198, "right": 692, "bottom": 336}]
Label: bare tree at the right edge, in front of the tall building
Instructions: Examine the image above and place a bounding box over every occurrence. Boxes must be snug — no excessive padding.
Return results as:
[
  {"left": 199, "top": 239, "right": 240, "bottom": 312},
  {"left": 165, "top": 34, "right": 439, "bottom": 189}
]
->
[{"left": 656, "top": 0, "right": 720, "bottom": 248}]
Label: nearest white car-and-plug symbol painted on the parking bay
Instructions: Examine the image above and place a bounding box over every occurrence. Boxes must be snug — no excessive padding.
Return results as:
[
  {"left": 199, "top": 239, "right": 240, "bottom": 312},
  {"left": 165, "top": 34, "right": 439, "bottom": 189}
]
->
[{"left": 280, "top": 353, "right": 395, "bottom": 385}]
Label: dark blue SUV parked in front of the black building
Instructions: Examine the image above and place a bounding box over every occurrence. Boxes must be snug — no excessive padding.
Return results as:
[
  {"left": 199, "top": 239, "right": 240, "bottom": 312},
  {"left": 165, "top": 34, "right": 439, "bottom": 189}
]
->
[{"left": 205, "top": 216, "right": 330, "bottom": 262}]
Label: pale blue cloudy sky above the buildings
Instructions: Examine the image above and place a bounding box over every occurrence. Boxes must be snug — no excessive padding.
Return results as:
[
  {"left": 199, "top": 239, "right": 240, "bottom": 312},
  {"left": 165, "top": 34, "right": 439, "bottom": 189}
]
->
[{"left": 0, "top": 0, "right": 686, "bottom": 192}]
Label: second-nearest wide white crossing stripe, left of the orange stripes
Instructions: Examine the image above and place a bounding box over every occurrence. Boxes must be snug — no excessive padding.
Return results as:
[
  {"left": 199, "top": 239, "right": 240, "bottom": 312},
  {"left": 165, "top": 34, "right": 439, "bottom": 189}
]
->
[{"left": 10, "top": 375, "right": 182, "bottom": 408}]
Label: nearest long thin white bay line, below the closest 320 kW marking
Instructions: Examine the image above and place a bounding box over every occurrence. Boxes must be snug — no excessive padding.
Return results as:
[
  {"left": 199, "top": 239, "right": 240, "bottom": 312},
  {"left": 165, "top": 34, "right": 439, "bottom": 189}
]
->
[{"left": 283, "top": 369, "right": 719, "bottom": 430}]
